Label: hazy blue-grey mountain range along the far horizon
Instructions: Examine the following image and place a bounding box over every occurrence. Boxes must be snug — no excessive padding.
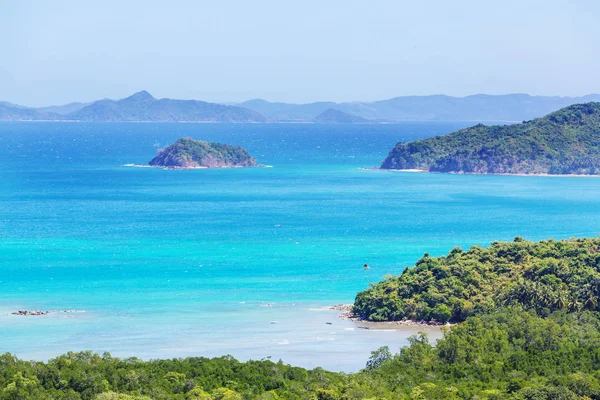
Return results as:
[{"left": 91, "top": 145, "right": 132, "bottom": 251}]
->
[{"left": 0, "top": 91, "right": 600, "bottom": 123}]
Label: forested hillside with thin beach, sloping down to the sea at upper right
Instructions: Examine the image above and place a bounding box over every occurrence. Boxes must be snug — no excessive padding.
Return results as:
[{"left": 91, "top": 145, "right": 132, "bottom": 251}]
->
[{"left": 381, "top": 103, "right": 600, "bottom": 175}]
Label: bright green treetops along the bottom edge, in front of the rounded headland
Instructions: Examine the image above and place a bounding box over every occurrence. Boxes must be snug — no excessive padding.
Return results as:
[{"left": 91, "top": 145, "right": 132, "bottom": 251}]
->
[{"left": 0, "top": 308, "right": 600, "bottom": 400}]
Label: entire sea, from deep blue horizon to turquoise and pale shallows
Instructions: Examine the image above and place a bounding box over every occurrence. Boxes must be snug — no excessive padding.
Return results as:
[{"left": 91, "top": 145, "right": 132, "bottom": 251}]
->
[{"left": 0, "top": 123, "right": 600, "bottom": 371}]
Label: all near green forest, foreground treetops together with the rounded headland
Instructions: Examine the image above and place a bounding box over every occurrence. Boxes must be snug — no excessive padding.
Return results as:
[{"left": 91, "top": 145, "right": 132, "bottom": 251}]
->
[{"left": 0, "top": 238, "right": 600, "bottom": 400}]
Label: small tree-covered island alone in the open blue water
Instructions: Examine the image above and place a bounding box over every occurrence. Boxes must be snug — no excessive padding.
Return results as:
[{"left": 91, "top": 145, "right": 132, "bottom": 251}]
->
[{"left": 149, "top": 138, "right": 257, "bottom": 169}]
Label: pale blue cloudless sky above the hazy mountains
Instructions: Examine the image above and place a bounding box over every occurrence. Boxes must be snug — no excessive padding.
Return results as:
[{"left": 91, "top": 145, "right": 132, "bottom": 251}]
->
[{"left": 0, "top": 0, "right": 600, "bottom": 106}]
